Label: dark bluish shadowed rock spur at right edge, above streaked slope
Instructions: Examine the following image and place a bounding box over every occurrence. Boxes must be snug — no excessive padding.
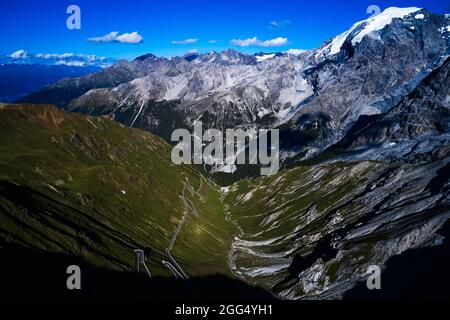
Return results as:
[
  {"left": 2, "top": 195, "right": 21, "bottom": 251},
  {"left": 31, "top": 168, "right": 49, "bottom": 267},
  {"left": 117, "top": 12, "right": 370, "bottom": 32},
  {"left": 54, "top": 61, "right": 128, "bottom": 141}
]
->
[{"left": 326, "top": 55, "right": 450, "bottom": 162}]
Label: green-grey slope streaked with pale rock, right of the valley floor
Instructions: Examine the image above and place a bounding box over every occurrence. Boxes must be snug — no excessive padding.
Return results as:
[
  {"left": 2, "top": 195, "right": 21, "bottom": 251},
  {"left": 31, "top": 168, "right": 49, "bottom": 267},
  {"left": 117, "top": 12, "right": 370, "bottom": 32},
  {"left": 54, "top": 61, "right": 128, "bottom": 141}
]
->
[{"left": 224, "top": 158, "right": 450, "bottom": 299}]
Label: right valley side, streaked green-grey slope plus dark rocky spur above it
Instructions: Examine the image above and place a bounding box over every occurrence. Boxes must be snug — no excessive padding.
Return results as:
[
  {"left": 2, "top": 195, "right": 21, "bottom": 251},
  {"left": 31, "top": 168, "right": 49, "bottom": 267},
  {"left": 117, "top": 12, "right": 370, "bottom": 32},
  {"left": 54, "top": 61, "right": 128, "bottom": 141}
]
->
[{"left": 224, "top": 48, "right": 450, "bottom": 299}]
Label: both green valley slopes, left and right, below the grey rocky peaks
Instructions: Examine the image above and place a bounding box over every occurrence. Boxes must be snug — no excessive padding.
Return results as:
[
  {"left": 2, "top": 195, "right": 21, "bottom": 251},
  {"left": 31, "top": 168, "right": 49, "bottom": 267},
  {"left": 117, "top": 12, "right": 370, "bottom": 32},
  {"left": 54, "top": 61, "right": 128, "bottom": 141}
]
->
[{"left": 0, "top": 105, "right": 450, "bottom": 299}]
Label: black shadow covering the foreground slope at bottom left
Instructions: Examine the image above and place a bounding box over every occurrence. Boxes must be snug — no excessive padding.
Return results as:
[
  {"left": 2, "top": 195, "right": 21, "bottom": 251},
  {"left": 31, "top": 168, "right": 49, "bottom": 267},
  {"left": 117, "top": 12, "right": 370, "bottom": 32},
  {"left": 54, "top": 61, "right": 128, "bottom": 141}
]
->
[{"left": 0, "top": 246, "right": 275, "bottom": 301}]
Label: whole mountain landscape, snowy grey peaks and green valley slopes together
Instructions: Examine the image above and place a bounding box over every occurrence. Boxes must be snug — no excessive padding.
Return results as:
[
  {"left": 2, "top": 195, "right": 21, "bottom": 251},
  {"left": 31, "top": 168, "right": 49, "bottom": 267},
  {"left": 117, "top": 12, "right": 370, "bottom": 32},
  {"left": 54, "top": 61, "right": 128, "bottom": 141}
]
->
[{"left": 0, "top": 8, "right": 450, "bottom": 299}]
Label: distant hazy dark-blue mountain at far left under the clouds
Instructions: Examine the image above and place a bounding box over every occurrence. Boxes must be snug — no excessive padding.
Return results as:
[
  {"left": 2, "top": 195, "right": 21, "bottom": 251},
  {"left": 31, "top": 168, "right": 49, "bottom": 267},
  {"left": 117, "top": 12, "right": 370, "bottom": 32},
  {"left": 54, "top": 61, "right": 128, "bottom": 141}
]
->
[{"left": 0, "top": 64, "right": 101, "bottom": 102}]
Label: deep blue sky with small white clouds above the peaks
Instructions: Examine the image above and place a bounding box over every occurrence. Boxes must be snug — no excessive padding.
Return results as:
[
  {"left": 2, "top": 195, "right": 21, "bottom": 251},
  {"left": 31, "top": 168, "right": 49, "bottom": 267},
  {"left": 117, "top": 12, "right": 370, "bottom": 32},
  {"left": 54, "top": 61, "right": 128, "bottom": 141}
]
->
[{"left": 0, "top": 0, "right": 450, "bottom": 59}]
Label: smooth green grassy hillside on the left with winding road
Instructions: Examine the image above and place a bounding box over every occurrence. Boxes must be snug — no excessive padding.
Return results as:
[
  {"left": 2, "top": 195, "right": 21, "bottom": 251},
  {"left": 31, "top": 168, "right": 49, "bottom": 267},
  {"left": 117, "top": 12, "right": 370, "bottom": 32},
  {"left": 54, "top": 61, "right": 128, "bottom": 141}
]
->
[{"left": 0, "top": 105, "right": 235, "bottom": 275}]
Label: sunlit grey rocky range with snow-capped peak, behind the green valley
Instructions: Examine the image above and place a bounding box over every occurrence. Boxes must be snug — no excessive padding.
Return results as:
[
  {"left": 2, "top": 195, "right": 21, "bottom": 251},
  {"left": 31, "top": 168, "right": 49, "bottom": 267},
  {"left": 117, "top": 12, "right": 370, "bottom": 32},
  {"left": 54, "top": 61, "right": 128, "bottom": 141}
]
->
[{"left": 18, "top": 8, "right": 450, "bottom": 159}]
